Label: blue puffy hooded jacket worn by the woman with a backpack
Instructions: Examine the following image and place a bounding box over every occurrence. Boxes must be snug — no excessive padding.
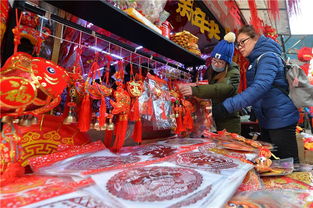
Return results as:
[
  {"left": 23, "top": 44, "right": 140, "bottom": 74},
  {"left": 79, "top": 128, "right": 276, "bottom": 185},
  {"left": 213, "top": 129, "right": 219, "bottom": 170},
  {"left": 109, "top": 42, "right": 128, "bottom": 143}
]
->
[{"left": 223, "top": 35, "right": 299, "bottom": 129}]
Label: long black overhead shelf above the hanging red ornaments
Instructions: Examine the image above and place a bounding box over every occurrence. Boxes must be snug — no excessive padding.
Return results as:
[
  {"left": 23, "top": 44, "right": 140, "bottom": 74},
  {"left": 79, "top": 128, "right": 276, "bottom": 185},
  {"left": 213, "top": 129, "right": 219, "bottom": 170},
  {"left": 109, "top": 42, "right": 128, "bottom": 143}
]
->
[{"left": 45, "top": 0, "right": 205, "bottom": 67}]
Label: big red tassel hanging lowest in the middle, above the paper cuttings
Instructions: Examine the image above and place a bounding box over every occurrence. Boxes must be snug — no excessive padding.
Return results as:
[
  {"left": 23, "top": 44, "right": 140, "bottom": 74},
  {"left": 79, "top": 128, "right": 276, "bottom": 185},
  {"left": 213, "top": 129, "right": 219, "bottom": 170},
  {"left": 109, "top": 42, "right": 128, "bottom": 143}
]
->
[{"left": 111, "top": 118, "right": 128, "bottom": 152}]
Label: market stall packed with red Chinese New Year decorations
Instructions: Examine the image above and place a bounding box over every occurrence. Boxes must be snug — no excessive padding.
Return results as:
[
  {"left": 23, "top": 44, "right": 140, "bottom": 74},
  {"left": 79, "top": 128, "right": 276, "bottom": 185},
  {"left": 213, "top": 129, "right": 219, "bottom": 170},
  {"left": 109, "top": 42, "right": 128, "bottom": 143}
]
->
[{"left": 0, "top": 1, "right": 313, "bottom": 208}]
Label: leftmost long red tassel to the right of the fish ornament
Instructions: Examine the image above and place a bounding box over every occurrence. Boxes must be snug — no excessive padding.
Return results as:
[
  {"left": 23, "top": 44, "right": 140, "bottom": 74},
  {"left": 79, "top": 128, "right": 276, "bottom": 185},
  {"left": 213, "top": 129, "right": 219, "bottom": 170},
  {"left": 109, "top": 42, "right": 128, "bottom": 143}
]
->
[{"left": 78, "top": 94, "right": 91, "bottom": 132}]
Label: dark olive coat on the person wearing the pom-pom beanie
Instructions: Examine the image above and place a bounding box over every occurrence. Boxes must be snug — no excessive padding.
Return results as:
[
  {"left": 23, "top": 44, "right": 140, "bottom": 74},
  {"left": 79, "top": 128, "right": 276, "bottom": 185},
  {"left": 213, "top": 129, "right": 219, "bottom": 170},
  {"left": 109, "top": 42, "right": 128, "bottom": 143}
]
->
[{"left": 192, "top": 63, "right": 241, "bottom": 134}]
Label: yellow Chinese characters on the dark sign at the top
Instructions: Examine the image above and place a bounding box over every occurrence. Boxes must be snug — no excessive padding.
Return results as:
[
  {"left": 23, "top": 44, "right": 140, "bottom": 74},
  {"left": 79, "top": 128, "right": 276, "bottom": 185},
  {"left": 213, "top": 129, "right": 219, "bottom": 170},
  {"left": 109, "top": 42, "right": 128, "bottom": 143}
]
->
[{"left": 176, "top": 0, "right": 221, "bottom": 40}]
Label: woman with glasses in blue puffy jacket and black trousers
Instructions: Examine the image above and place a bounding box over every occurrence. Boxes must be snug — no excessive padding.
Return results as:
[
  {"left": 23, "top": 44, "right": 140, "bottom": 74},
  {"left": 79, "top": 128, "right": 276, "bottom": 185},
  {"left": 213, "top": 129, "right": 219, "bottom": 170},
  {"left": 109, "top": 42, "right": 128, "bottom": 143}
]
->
[{"left": 213, "top": 25, "right": 299, "bottom": 163}]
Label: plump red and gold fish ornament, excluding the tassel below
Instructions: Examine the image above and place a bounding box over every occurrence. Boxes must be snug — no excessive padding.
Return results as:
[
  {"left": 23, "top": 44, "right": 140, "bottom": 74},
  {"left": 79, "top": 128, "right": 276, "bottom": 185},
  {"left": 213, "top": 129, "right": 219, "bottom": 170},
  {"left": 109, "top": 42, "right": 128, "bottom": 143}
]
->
[{"left": 0, "top": 25, "right": 69, "bottom": 117}]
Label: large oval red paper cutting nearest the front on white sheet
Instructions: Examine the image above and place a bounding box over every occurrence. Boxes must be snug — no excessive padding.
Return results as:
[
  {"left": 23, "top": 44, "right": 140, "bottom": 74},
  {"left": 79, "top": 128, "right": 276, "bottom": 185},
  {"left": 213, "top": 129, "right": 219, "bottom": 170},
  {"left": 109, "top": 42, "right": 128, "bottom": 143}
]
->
[{"left": 107, "top": 167, "right": 203, "bottom": 202}]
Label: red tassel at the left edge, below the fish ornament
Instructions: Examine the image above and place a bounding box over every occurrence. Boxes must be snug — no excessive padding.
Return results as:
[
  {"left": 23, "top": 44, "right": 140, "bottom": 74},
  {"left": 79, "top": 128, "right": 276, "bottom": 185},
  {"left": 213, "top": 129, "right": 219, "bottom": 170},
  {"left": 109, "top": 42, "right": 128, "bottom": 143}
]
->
[{"left": 0, "top": 162, "right": 25, "bottom": 187}]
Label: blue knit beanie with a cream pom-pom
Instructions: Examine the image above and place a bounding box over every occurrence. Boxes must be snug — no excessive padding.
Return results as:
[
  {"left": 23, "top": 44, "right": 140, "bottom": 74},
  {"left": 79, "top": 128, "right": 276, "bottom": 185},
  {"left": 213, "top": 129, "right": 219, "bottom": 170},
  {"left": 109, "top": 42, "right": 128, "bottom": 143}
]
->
[{"left": 211, "top": 32, "right": 236, "bottom": 64}]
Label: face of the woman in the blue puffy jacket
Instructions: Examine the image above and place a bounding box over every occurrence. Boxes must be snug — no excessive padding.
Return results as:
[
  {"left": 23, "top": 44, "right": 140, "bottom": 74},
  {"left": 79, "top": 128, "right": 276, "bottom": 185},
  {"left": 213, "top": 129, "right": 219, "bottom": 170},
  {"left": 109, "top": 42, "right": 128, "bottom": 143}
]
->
[{"left": 236, "top": 33, "right": 257, "bottom": 57}]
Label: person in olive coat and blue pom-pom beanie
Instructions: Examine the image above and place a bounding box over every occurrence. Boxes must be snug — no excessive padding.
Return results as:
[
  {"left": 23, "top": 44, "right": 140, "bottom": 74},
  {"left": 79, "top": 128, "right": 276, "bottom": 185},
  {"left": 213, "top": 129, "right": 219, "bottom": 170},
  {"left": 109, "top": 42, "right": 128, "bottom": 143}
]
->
[{"left": 179, "top": 33, "right": 241, "bottom": 134}]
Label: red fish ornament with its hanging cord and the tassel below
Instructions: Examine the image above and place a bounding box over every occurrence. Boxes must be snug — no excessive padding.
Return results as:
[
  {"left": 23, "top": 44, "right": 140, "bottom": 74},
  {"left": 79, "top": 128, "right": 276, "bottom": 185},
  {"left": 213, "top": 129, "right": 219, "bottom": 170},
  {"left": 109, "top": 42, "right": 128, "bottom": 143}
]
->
[{"left": 0, "top": 10, "right": 69, "bottom": 183}]
